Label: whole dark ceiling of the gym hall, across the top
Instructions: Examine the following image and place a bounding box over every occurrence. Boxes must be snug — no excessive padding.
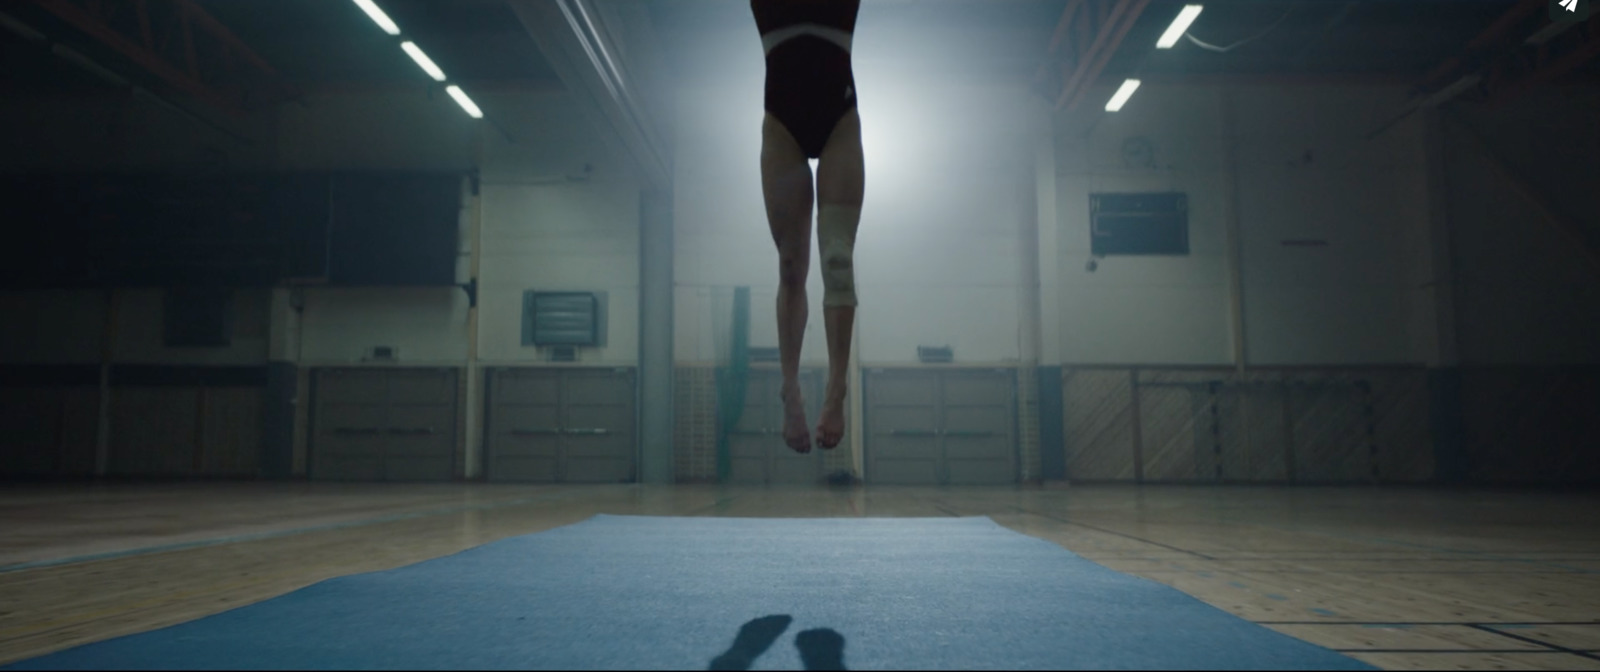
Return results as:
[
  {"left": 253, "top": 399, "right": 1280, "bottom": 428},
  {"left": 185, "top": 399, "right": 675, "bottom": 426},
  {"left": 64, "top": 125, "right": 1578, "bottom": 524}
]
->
[{"left": 0, "top": 0, "right": 1600, "bottom": 116}]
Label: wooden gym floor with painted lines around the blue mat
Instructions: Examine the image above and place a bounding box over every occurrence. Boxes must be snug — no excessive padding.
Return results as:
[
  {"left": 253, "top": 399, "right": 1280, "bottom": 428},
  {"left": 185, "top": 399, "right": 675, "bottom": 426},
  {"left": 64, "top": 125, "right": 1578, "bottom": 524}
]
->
[{"left": 0, "top": 483, "right": 1600, "bottom": 669}]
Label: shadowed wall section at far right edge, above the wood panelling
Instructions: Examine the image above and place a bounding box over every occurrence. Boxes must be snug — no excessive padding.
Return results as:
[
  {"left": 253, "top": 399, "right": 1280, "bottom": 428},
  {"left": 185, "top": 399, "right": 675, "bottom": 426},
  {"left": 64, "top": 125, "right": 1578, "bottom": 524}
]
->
[{"left": 1446, "top": 86, "right": 1600, "bottom": 365}]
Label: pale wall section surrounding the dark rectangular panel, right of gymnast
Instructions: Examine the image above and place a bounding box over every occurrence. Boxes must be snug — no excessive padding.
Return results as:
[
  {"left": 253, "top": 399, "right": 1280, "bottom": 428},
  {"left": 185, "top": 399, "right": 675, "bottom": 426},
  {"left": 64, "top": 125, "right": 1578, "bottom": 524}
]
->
[{"left": 1046, "top": 86, "right": 1230, "bottom": 365}]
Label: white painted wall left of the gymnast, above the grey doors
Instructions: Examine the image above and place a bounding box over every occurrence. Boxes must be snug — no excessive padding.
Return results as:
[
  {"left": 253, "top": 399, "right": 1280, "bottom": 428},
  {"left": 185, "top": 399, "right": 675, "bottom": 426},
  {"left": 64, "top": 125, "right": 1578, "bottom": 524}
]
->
[{"left": 0, "top": 86, "right": 638, "bottom": 365}]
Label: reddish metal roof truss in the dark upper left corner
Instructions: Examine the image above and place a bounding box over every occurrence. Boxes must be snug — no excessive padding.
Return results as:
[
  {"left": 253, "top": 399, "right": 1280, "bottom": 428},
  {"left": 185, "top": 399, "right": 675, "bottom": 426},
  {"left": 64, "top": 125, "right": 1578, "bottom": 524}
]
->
[{"left": 30, "top": 0, "right": 299, "bottom": 115}]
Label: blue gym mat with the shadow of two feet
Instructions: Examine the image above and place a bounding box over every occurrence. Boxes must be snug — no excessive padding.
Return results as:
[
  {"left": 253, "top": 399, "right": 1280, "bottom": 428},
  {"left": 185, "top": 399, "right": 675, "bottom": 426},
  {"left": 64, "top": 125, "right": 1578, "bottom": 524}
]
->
[{"left": 6, "top": 515, "right": 1373, "bottom": 669}]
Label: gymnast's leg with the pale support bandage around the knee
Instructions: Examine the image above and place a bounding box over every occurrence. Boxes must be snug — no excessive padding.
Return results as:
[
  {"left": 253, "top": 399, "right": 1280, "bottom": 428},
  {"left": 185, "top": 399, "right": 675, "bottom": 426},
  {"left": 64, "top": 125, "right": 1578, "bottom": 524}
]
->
[{"left": 816, "top": 107, "right": 866, "bottom": 448}]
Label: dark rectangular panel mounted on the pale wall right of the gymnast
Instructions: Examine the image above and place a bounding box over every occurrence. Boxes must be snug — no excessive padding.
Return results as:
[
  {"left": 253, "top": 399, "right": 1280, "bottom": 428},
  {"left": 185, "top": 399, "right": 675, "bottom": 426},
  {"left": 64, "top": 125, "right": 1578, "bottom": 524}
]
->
[{"left": 1090, "top": 192, "right": 1189, "bottom": 256}]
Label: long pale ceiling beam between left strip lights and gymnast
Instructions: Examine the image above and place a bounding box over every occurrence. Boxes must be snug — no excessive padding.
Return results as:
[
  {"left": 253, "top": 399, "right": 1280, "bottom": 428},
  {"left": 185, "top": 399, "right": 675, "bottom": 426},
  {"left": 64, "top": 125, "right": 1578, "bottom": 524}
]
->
[{"left": 507, "top": 0, "right": 672, "bottom": 192}]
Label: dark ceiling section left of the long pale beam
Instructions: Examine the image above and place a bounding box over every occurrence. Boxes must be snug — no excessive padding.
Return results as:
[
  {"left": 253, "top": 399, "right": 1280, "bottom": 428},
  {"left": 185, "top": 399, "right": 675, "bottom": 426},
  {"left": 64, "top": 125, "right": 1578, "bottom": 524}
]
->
[{"left": 0, "top": 0, "right": 560, "bottom": 107}]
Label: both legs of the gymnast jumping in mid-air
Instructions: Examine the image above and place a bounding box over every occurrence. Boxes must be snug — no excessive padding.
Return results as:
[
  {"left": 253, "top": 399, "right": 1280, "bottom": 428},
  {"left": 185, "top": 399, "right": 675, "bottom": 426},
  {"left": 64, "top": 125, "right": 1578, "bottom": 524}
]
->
[{"left": 762, "top": 107, "right": 866, "bottom": 453}]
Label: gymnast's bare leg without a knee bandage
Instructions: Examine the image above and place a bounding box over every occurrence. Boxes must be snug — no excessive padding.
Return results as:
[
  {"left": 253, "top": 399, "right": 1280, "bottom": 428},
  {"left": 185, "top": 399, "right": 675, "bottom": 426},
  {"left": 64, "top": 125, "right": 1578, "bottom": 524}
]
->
[{"left": 762, "top": 114, "right": 813, "bottom": 453}]
